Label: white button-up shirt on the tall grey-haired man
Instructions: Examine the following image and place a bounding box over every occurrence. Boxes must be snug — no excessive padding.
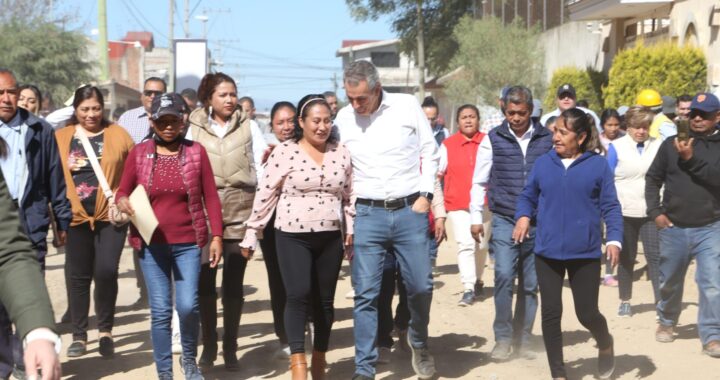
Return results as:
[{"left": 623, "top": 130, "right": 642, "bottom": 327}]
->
[{"left": 335, "top": 91, "right": 438, "bottom": 200}]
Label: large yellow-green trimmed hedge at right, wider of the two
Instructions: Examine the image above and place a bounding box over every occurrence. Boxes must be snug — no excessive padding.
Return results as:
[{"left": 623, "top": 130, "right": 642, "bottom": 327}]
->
[{"left": 604, "top": 42, "right": 707, "bottom": 108}]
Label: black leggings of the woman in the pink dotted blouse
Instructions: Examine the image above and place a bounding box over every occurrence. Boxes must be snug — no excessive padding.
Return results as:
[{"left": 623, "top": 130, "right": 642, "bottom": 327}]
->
[{"left": 275, "top": 230, "right": 343, "bottom": 354}]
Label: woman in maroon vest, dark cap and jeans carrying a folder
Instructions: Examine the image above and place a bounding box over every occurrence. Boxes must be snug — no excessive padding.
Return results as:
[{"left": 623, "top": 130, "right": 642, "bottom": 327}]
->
[{"left": 117, "top": 93, "right": 223, "bottom": 380}]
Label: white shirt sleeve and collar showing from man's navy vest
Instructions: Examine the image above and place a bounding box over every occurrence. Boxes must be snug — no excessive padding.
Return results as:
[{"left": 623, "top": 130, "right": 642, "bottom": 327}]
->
[{"left": 470, "top": 123, "right": 535, "bottom": 224}]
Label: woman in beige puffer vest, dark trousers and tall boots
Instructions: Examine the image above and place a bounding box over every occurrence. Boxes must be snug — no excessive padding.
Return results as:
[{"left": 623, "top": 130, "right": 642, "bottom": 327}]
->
[{"left": 186, "top": 73, "right": 267, "bottom": 371}]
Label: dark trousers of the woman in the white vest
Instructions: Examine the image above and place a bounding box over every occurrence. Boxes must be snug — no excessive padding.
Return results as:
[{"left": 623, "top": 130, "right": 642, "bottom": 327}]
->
[{"left": 618, "top": 217, "right": 660, "bottom": 303}]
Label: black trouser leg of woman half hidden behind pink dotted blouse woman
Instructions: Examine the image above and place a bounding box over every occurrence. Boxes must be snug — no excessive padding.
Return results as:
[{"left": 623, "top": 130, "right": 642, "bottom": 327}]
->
[{"left": 260, "top": 215, "right": 287, "bottom": 344}]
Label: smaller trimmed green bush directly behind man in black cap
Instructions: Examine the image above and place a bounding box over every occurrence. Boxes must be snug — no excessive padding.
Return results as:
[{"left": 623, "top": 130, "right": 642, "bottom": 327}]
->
[{"left": 543, "top": 66, "right": 603, "bottom": 112}]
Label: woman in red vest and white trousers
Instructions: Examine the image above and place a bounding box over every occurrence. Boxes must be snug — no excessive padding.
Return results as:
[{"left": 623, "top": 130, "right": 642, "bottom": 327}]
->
[{"left": 440, "top": 104, "right": 490, "bottom": 306}]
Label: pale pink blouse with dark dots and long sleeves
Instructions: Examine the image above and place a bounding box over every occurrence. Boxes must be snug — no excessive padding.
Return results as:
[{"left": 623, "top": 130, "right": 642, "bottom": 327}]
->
[{"left": 240, "top": 141, "right": 355, "bottom": 249}]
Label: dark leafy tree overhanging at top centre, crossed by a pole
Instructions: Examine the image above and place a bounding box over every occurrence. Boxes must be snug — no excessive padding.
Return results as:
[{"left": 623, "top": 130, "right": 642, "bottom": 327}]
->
[{"left": 345, "top": 0, "right": 473, "bottom": 74}]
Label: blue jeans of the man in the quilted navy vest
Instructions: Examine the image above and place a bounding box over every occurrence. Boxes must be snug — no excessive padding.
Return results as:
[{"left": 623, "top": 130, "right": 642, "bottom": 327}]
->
[{"left": 490, "top": 214, "right": 538, "bottom": 344}]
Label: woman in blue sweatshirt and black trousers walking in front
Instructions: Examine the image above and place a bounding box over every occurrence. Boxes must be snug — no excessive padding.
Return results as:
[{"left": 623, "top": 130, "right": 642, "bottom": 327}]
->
[{"left": 513, "top": 108, "right": 623, "bottom": 379}]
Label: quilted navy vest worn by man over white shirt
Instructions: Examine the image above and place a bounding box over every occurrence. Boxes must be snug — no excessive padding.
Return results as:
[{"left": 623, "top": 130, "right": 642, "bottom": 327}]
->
[{"left": 488, "top": 120, "right": 553, "bottom": 218}]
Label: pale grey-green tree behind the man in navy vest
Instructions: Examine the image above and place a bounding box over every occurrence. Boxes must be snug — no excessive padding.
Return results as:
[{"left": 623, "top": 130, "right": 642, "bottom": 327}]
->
[{"left": 447, "top": 16, "right": 544, "bottom": 105}]
